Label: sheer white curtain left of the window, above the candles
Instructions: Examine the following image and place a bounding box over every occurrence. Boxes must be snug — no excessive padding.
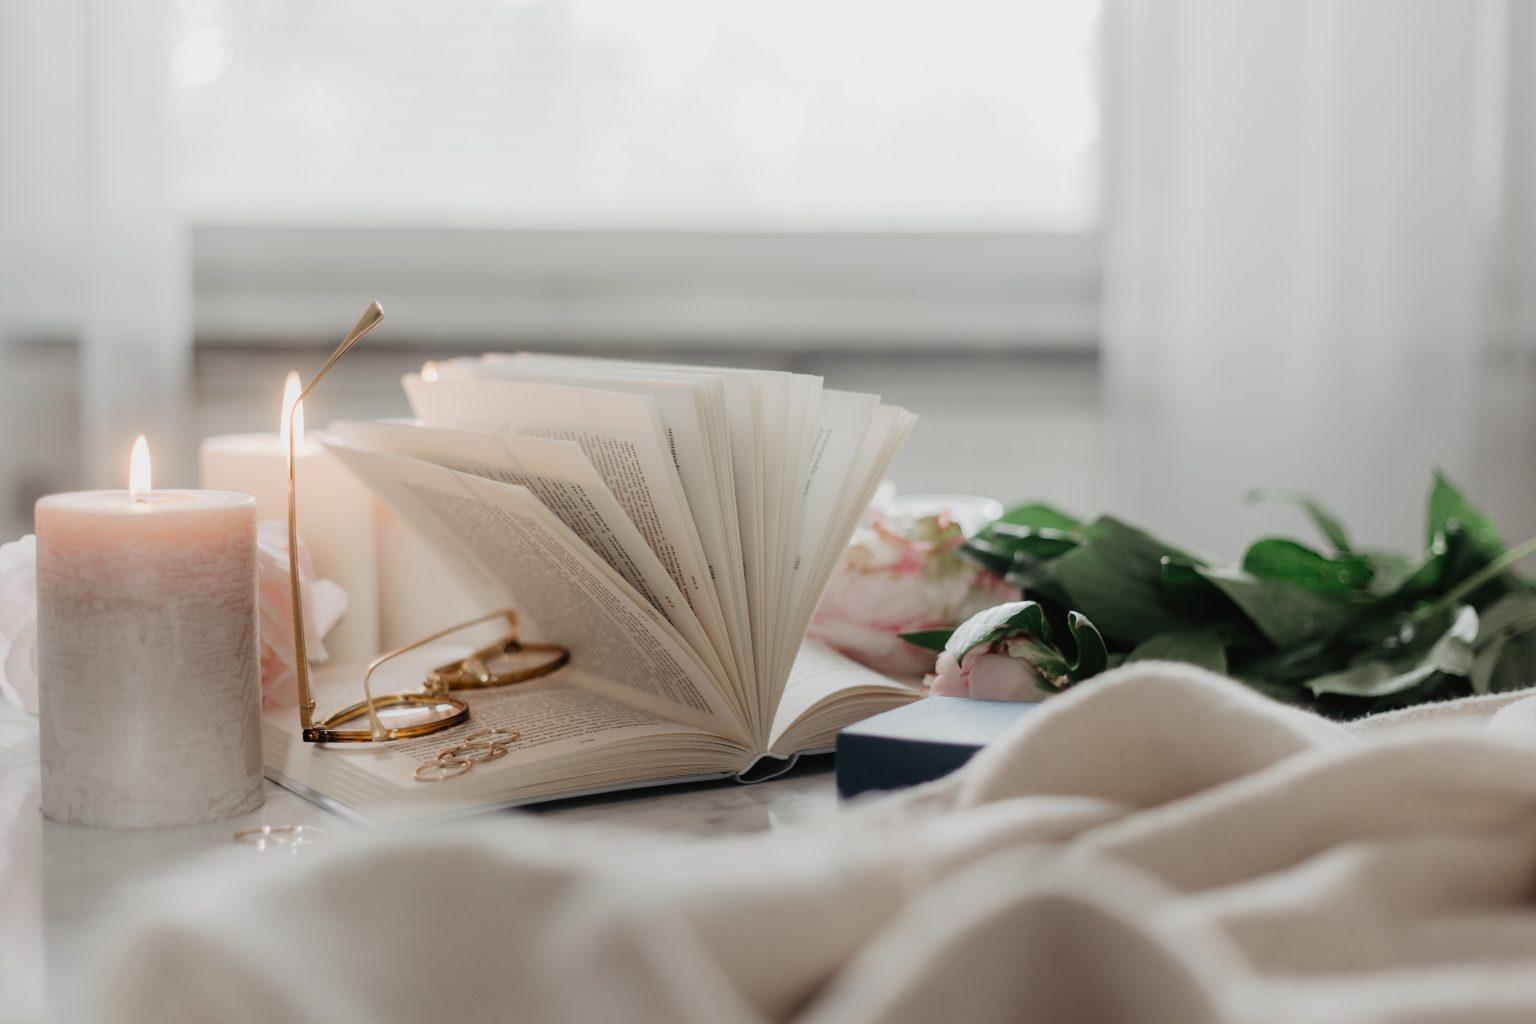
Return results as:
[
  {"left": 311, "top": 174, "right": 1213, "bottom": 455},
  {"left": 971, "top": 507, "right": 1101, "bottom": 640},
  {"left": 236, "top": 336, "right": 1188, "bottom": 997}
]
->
[{"left": 0, "top": 0, "right": 192, "bottom": 493}]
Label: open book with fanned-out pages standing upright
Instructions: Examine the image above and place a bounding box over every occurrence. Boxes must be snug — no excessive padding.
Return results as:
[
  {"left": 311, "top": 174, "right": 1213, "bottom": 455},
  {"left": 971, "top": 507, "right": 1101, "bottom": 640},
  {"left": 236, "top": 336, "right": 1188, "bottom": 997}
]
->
[{"left": 264, "top": 353, "right": 917, "bottom": 821}]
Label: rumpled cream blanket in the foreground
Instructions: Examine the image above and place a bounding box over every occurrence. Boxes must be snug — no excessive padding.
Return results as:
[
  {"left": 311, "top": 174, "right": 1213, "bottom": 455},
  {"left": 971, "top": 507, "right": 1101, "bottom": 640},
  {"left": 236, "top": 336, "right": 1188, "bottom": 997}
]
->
[{"left": 97, "top": 665, "right": 1536, "bottom": 1024}]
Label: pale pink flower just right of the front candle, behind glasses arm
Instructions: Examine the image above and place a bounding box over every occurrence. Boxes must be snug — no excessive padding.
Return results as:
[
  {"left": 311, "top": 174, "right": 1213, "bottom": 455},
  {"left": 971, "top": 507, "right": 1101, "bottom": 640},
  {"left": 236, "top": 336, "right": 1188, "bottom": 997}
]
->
[{"left": 257, "top": 519, "right": 347, "bottom": 708}]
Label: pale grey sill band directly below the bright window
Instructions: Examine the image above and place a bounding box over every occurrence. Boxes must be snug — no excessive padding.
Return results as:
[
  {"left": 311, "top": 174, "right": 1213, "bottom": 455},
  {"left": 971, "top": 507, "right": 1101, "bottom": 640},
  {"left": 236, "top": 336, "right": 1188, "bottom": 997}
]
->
[{"left": 192, "top": 224, "right": 1098, "bottom": 352}]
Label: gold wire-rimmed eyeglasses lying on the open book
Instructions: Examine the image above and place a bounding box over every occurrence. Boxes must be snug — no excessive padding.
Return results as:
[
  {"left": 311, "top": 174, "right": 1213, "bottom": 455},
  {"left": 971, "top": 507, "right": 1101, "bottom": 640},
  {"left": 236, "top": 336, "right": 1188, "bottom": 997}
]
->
[{"left": 287, "top": 302, "right": 570, "bottom": 746}]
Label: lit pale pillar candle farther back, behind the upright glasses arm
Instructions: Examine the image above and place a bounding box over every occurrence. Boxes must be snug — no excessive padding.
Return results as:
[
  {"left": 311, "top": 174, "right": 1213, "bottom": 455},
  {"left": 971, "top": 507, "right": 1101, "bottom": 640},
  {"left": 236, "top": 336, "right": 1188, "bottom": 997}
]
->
[{"left": 198, "top": 373, "right": 379, "bottom": 662}]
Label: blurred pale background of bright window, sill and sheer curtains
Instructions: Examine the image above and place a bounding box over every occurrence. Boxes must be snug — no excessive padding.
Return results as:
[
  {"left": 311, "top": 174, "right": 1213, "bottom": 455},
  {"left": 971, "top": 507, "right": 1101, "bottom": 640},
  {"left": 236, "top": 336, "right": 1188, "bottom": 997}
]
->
[{"left": 0, "top": 0, "right": 1536, "bottom": 554}]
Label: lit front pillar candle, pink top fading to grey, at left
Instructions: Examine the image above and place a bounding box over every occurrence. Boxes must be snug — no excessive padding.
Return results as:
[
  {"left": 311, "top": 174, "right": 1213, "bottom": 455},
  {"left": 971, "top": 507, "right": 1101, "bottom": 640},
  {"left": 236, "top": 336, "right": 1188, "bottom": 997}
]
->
[{"left": 37, "top": 438, "right": 263, "bottom": 827}]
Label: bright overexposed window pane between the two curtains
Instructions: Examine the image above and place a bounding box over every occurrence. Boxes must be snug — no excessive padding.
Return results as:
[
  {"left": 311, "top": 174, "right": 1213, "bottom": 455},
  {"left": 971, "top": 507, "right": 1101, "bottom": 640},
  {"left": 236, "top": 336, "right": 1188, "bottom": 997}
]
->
[{"left": 170, "top": 0, "right": 1098, "bottom": 232}]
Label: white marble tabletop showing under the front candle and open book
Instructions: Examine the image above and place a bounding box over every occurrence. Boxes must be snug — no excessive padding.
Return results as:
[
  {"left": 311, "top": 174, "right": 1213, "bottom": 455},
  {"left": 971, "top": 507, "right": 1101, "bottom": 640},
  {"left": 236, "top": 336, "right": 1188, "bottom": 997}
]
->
[{"left": 0, "top": 702, "right": 837, "bottom": 1022}]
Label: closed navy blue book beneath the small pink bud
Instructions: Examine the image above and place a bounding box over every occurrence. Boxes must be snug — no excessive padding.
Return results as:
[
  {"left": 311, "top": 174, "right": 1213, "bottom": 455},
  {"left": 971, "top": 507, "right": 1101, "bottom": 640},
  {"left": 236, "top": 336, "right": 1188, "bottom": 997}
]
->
[{"left": 837, "top": 697, "right": 1040, "bottom": 797}]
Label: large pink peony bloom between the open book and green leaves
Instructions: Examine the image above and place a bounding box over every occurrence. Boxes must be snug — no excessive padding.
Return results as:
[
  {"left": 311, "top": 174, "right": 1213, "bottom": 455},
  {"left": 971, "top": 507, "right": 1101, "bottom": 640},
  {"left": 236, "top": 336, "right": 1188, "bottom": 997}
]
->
[{"left": 809, "top": 497, "right": 1018, "bottom": 676}]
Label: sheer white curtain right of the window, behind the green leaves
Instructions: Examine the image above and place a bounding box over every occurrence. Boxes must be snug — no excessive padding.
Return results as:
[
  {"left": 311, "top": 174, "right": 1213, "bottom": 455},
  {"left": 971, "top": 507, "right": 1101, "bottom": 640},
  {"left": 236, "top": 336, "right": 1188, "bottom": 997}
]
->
[{"left": 1103, "top": 0, "right": 1536, "bottom": 553}]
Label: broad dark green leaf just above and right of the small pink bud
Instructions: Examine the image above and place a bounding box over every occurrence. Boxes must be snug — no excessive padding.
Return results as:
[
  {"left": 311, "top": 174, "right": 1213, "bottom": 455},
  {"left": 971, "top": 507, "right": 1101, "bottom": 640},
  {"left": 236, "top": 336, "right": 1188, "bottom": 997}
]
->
[{"left": 1043, "top": 516, "right": 1200, "bottom": 646}]
